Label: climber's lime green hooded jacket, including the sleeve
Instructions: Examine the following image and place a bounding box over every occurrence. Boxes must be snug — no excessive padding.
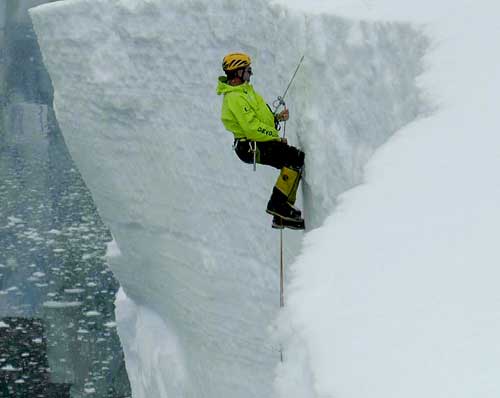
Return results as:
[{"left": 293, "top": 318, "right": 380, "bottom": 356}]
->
[{"left": 217, "top": 76, "right": 280, "bottom": 141}]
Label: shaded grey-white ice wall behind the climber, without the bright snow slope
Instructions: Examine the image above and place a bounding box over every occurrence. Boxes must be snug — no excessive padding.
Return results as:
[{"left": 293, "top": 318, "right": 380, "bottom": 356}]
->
[{"left": 31, "top": 0, "right": 427, "bottom": 397}]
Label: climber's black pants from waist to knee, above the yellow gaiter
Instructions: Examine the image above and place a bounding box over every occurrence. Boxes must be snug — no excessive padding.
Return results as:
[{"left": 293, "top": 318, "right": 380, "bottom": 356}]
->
[{"left": 235, "top": 140, "right": 305, "bottom": 170}]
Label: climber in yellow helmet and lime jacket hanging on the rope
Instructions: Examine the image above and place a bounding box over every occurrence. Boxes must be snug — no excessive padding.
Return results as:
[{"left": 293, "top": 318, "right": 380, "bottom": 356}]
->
[{"left": 217, "top": 53, "right": 305, "bottom": 229}]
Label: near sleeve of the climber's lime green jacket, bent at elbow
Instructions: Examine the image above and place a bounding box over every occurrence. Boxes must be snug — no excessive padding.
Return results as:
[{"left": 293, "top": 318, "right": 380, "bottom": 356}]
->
[{"left": 227, "top": 91, "right": 280, "bottom": 142}]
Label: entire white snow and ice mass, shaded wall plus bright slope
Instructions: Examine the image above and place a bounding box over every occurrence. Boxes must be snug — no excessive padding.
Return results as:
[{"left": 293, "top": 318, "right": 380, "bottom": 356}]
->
[{"left": 31, "top": 0, "right": 500, "bottom": 398}]
